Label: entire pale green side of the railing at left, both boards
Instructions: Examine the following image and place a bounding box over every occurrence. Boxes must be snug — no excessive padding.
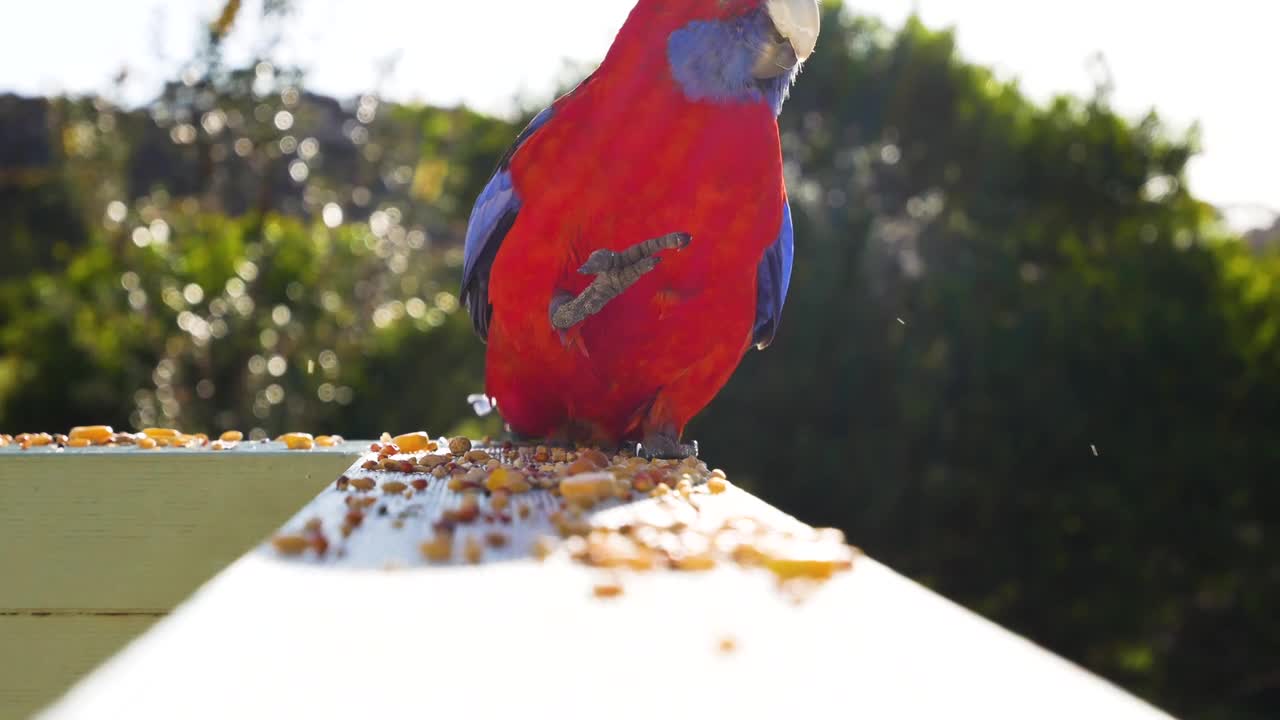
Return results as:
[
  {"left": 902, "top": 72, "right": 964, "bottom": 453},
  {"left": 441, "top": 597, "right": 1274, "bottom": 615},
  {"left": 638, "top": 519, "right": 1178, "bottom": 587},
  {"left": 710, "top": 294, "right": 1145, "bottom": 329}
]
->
[{"left": 0, "top": 442, "right": 367, "bottom": 720}]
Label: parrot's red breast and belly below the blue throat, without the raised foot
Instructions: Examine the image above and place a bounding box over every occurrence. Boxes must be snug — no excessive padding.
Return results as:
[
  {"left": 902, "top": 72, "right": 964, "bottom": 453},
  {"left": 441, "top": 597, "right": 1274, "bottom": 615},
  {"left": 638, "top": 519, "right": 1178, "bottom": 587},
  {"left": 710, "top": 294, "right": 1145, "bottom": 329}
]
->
[{"left": 486, "top": 96, "right": 783, "bottom": 441}]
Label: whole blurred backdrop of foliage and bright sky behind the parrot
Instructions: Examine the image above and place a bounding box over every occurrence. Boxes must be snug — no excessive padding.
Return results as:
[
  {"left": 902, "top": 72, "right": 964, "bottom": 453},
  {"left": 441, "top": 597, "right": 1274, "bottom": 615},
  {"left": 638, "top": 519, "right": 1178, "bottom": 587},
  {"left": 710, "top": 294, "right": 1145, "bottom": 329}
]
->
[{"left": 0, "top": 0, "right": 1280, "bottom": 720}]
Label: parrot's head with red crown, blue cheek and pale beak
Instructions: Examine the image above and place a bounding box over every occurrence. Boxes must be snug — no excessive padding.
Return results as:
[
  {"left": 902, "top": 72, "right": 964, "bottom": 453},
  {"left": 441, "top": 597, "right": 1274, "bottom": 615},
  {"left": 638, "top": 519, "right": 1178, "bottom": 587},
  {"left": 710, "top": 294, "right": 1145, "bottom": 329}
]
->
[{"left": 607, "top": 0, "right": 822, "bottom": 110}]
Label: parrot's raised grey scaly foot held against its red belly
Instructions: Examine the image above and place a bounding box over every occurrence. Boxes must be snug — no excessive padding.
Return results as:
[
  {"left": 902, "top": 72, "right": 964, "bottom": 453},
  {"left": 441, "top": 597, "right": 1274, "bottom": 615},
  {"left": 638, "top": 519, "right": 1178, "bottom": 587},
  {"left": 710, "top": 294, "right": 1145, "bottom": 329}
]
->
[{"left": 550, "top": 232, "right": 692, "bottom": 332}]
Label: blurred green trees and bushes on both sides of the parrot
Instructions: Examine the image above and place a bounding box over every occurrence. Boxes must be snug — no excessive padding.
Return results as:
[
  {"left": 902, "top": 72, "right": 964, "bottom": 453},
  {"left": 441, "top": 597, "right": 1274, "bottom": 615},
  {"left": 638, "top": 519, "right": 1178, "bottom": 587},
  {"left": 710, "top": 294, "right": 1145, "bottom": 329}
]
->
[{"left": 0, "top": 3, "right": 1280, "bottom": 719}]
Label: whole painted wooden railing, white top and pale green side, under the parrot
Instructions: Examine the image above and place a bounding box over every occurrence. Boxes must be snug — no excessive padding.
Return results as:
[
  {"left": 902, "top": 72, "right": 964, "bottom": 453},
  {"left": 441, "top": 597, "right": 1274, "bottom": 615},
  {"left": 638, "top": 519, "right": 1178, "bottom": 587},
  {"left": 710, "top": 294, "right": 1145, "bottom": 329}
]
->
[{"left": 0, "top": 443, "right": 1167, "bottom": 719}]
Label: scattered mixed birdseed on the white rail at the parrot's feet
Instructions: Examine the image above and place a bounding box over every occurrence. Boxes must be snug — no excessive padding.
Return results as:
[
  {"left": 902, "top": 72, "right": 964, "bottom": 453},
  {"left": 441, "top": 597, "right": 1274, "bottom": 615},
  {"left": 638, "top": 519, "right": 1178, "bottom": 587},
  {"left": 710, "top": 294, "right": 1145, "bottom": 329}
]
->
[{"left": 273, "top": 432, "right": 858, "bottom": 598}]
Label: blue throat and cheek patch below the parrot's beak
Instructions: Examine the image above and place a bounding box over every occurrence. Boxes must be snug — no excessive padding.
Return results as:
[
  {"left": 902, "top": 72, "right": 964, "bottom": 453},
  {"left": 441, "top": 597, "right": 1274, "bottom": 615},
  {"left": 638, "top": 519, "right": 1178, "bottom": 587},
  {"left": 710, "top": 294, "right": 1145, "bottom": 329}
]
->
[{"left": 667, "top": 8, "right": 799, "bottom": 115}]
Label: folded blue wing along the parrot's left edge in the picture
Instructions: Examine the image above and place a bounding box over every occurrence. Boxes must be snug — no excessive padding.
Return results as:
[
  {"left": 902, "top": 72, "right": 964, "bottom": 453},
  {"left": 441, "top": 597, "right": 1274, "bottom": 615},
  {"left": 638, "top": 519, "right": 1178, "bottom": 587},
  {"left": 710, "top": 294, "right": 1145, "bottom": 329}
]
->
[{"left": 462, "top": 108, "right": 553, "bottom": 340}]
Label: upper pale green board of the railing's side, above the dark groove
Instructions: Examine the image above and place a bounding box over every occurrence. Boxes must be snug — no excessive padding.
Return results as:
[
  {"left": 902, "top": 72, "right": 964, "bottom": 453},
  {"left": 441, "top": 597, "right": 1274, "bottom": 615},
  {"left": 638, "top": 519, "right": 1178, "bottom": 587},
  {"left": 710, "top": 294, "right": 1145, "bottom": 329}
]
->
[{"left": 0, "top": 443, "right": 361, "bottom": 612}]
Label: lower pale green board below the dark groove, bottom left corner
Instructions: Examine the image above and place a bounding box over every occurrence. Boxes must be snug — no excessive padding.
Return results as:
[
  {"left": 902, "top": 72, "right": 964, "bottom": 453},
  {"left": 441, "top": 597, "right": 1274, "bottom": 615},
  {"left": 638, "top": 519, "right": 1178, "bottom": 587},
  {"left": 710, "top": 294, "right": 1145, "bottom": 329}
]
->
[{"left": 0, "top": 615, "right": 157, "bottom": 720}]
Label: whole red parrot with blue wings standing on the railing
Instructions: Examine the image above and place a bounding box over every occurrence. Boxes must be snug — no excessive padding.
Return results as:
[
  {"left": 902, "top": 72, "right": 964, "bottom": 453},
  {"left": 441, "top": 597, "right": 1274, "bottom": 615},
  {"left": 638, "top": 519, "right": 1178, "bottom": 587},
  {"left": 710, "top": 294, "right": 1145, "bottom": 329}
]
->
[{"left": 462, "top": 0, "right": 819, "bottom": 457}]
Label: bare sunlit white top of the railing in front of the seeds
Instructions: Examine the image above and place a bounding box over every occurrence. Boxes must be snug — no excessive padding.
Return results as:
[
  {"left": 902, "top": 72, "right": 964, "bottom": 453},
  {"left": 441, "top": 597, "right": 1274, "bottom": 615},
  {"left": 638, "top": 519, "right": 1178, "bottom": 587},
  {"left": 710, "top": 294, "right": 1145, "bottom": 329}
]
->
[{"left": 35, "top": 458, "right": 1167, "bottom": 720}]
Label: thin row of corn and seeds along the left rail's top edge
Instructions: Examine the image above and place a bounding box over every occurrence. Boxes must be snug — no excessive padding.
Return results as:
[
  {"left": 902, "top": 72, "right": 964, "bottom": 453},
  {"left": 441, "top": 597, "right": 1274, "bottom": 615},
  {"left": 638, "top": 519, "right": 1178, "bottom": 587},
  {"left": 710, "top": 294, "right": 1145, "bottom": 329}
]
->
[{"left": 0, "top": 425, "right": 346, "bottom": 450}]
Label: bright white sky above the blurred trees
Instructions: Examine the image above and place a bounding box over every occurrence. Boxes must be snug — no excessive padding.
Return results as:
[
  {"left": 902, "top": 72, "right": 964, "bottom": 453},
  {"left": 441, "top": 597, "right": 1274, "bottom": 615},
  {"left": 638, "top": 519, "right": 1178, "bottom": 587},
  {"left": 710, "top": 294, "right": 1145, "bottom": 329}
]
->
[{"left": 0, "top": 0, "right": 1280, "bottom": 224}]
